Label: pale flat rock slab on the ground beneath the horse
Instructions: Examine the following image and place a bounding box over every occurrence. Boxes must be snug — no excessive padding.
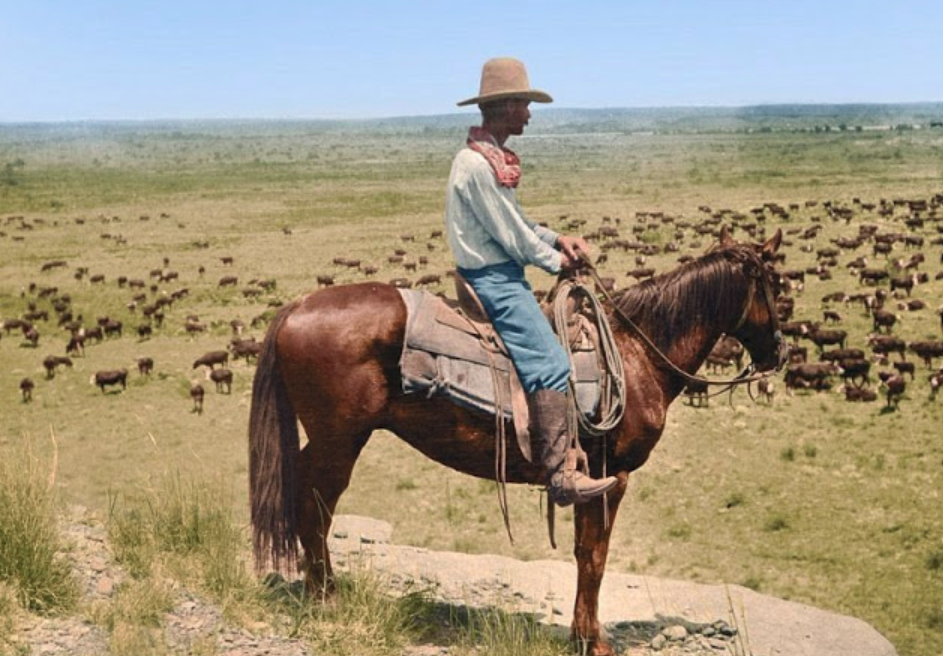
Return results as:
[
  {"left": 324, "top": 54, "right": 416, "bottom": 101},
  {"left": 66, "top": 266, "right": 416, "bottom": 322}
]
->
[{"left": 329, "top": 515, "right": 897, "bottom": 656}]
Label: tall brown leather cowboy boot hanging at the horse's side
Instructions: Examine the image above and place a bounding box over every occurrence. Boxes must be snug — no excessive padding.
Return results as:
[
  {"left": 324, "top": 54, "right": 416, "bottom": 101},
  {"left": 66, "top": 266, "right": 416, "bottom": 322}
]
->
[{"left": 527, "top": 390, "right": 618, "bottom": 507}]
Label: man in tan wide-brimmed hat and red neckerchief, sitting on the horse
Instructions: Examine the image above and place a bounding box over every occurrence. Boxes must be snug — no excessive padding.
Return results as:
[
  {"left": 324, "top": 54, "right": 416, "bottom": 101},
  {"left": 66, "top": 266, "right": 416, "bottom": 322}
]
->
[{"left": 445, "top": 57, "right": 616, "bottom": 506}]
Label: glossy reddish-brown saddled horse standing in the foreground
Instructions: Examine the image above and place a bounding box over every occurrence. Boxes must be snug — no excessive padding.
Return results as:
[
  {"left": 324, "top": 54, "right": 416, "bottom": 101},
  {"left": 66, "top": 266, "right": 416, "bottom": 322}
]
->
[{"left": 249, "top": 231, "right": 785, "bottom": 656}]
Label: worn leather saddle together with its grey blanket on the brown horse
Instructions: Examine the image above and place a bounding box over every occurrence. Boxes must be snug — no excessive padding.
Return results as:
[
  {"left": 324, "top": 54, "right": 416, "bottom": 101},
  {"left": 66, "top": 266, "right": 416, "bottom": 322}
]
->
[{"left": 399, "top": 273, "right": 604, "bottom": 460}]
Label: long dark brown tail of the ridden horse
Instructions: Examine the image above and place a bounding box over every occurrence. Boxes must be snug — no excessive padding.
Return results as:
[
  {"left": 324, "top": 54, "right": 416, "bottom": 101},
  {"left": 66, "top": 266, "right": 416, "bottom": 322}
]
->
[{"left": 249, "top": 301, "right": 300, "bottom": 572}]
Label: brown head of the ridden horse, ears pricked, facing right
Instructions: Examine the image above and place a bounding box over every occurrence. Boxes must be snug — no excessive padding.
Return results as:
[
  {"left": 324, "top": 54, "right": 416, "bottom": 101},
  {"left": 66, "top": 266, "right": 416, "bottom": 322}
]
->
[{"left": 720, "top": 228, "right": 788, "bottom": 371}]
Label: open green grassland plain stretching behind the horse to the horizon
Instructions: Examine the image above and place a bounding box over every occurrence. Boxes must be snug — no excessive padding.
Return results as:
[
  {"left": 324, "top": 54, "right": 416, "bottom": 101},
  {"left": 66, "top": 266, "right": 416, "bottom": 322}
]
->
[{"left": 0, "top": 106, "right": 943, "bottom": 656}]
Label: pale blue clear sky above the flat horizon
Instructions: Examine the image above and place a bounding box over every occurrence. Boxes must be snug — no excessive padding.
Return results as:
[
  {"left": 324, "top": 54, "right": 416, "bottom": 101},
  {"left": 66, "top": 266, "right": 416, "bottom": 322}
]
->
[{"left": 0, "top": 0, "right": 943, "bottom": 121}]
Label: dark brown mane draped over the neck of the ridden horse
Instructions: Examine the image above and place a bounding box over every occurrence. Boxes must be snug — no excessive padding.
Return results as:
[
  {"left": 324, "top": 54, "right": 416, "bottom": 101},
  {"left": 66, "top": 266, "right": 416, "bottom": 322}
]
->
[{"left": 616, "top": 244, "right": 756, "bottom": 345}]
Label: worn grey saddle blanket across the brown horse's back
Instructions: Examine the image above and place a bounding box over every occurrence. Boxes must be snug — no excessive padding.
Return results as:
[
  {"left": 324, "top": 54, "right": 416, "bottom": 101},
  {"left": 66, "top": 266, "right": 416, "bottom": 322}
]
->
[{"left": 399, "top": 289, "right": 601, "bottom": 419}]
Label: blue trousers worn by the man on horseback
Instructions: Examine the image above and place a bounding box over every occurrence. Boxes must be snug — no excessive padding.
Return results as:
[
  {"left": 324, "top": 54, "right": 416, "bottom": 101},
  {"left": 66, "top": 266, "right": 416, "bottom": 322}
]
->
[{"left": 458, "top": 262, "right": 570, "bottom": 394}]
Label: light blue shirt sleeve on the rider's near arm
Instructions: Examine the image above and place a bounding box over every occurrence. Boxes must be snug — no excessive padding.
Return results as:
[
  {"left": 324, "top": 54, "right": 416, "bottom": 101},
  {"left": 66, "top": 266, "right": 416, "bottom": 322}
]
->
[{"left": 465, "top": 162, "right": 562, "bottom": 273}]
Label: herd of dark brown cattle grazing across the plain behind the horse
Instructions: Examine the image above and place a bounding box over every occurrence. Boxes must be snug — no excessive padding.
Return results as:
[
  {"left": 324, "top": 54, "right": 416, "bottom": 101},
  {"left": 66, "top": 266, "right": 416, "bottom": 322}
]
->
[{"left": 0, "top": 194, "right": 943, "bottom": 413}]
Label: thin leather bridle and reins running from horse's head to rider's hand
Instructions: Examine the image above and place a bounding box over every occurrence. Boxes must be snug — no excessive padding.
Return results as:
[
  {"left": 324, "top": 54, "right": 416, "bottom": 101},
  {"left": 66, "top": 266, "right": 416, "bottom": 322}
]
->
[{"left": 580, "top": 247, "right": 788, "bottom": 393}]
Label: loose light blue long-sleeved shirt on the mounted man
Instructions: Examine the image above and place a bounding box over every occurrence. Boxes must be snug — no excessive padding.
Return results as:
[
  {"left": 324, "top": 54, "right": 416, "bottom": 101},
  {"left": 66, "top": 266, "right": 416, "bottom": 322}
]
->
[{"left": 445, "top": 147, "right": 561, "bottom": 273}]
